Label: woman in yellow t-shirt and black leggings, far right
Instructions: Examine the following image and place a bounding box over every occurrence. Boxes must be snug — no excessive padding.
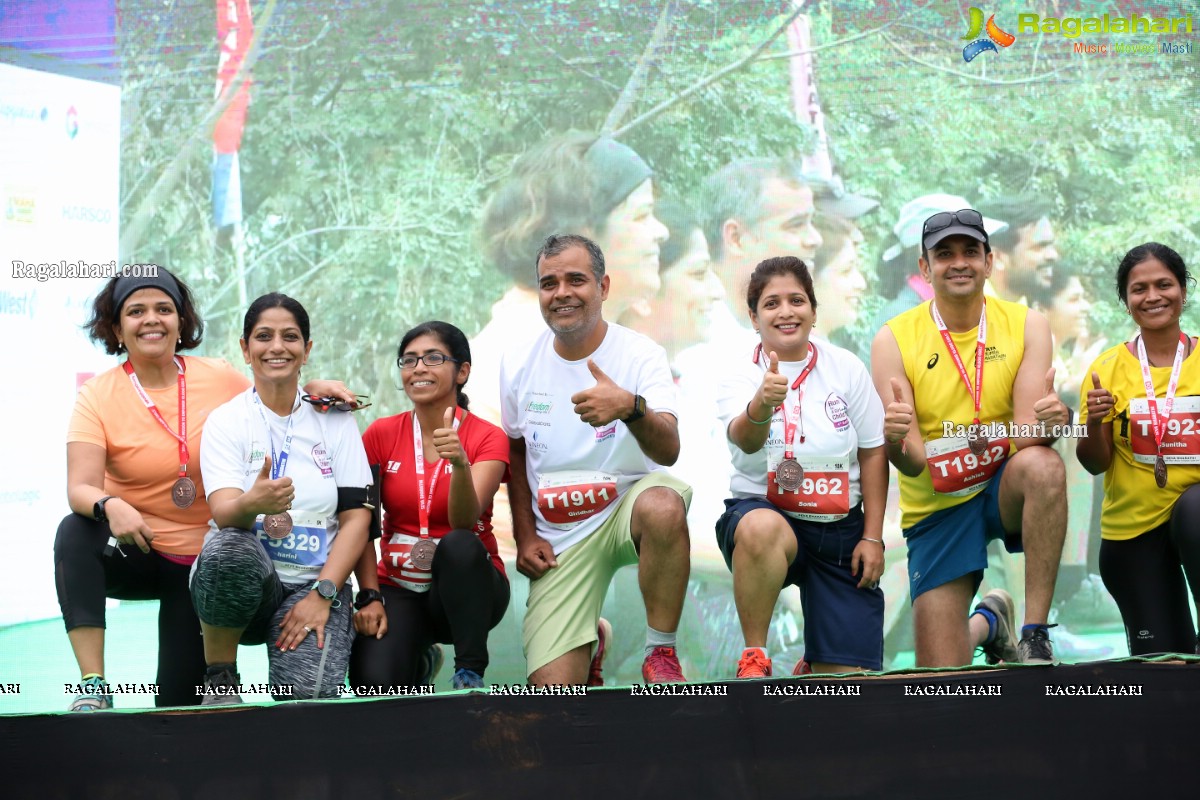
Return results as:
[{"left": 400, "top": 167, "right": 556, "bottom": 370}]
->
[{"left": 1075, "top": 242, "right": 1200, "bottom": 655}]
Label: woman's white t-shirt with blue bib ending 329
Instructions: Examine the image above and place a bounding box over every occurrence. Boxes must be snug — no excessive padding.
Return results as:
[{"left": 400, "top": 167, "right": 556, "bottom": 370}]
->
[{"left": 200, "top": 389, "right": 371, "bottom": 584}]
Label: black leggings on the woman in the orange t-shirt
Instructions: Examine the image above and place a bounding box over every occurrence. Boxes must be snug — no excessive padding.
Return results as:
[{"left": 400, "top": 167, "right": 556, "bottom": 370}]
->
[{"left": 54, "top": 513, "right": 205, "bottom": 705}]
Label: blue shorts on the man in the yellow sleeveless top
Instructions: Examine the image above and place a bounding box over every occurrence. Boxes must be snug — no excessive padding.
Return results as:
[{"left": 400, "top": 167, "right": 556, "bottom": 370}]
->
[{"left": 904, "top": 463, "right": 1024, "bottom": 600}]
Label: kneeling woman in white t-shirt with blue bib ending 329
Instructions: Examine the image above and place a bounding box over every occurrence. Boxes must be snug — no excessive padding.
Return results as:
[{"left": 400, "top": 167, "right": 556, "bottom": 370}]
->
[{"left": 192, "top": 294, "right": 371, "bottom": 705}]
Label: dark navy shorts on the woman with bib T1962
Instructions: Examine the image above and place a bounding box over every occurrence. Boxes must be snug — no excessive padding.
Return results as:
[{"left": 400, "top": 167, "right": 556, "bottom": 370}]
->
[{"left": 716, "top": 498, "right": 883, "bottom": 670}]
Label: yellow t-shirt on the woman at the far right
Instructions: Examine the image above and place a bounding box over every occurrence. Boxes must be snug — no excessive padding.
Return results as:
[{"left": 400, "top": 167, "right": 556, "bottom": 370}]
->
[{"left": 1079, "top": 343, "right": 1200, "bottom": 540}]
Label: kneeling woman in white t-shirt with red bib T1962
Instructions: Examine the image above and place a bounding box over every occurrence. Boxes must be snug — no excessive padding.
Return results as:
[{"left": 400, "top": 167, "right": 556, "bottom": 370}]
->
[{"left": 716, "top": 255, "right": 888, "bottom": 678}]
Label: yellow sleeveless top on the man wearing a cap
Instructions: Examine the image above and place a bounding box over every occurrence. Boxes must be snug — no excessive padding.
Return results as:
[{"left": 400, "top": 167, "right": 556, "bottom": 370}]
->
[{"left": 887, "top": 297, "right": 1028, "bottom": 529}]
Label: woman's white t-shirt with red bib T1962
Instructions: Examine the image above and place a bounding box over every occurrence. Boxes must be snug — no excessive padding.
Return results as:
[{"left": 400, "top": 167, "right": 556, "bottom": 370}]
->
[{"left": 718, "top": 341, "right": 883, "bottom": 522}]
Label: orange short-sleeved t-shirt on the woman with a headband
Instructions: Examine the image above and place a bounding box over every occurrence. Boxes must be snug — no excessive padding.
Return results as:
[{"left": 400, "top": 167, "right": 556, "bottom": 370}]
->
[{"left": 67, "top": 356, "right": 250, "bottom": 555}]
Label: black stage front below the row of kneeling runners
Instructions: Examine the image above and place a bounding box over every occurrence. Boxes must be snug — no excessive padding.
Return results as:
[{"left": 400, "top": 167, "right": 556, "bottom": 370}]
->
[{"left": 0, "top": 658, "right": 1200, "bottom": 800}]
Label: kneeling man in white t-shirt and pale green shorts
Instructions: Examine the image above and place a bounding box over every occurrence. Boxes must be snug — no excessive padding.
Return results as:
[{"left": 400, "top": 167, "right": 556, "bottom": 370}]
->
[{"left": 500, "top": 234, "right": 691, "bottom": 686}]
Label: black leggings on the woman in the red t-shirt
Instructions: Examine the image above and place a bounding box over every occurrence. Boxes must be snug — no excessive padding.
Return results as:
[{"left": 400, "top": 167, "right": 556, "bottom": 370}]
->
[{"left": 350, "top": 530, "right": 509, "bottom": 688}]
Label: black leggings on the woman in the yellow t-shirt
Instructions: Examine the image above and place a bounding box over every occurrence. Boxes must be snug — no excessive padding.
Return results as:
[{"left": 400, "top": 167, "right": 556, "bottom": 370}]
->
[{"left": 1100, "top": 485, "right": 1200, "bottom": 656}]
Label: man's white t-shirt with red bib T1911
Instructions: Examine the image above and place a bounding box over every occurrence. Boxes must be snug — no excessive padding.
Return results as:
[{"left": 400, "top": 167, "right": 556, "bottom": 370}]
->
[{"left": 500, "top": 323, "right": 678, "bottom": 554}]
